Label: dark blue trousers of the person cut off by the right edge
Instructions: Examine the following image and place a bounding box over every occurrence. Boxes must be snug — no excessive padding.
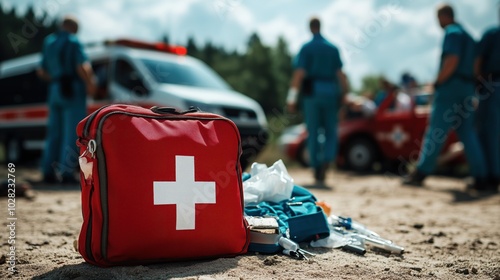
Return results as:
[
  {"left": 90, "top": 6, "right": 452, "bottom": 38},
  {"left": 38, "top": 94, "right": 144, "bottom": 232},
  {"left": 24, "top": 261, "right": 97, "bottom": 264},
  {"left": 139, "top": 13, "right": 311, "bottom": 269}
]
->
[{"left": 476, "top": 79, "right": 500, "bottom": 179}]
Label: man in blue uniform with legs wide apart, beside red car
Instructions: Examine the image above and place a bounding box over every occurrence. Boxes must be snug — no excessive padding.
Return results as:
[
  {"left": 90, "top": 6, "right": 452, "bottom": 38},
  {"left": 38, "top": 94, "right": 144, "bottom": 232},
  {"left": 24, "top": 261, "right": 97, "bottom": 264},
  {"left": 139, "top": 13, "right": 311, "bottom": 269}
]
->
[{"left": 403, "top": 5, "right": 487, "bottom": 188}]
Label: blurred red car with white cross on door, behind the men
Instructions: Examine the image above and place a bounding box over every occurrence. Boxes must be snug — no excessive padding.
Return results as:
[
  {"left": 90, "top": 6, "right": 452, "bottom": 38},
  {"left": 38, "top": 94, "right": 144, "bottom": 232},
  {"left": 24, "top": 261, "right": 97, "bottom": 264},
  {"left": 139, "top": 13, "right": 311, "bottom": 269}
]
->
[{"left": 280, "top": 91, "right": 463, "bottom": 171}]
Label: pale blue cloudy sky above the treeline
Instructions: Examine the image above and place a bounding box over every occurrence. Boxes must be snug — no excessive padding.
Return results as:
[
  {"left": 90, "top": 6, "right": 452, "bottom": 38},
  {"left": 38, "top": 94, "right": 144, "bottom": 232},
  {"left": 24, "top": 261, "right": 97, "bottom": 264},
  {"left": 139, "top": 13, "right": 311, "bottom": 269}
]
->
[{"left": 0, "top": 0, "right": 500, "bottom": 87}]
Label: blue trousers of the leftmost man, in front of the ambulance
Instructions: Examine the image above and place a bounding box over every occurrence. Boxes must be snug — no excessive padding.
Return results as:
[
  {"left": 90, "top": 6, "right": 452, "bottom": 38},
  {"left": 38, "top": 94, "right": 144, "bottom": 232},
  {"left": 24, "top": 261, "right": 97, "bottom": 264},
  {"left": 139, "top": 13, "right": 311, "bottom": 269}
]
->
[{"left": 42, "top": 81, "right": 87, "bottom": 179}]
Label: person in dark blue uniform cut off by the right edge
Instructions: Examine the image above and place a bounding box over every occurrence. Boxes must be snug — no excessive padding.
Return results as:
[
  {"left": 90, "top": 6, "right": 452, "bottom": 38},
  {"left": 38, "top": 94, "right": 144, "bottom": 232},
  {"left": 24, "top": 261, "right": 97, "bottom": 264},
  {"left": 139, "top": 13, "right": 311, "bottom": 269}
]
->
[{"left": 475, "top": 9, "right": 500, "bottom": 192}]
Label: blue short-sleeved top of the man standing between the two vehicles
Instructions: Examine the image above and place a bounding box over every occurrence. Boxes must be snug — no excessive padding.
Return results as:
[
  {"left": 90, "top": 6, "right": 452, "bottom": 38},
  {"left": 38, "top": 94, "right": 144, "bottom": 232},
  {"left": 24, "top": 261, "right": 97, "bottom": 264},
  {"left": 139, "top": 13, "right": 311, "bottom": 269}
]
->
[{"left": 293, "top": 33, "right": 342, "bottom": 82}]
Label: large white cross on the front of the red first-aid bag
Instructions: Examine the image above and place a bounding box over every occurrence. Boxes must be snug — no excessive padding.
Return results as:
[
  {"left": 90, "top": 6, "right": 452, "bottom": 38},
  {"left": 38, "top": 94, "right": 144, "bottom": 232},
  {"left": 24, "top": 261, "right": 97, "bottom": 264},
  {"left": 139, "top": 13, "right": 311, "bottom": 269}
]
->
[{"left": 153, "top": 156, "right": 215, "bottom": 230}]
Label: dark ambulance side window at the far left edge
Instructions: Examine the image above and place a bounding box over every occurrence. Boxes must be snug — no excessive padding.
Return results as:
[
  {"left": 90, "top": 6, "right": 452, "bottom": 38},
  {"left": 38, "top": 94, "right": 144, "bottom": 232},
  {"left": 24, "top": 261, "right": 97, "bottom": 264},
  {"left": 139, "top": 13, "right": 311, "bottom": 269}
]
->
[{"left": 0, "top": 70, "right": 47, "bottom": 107}]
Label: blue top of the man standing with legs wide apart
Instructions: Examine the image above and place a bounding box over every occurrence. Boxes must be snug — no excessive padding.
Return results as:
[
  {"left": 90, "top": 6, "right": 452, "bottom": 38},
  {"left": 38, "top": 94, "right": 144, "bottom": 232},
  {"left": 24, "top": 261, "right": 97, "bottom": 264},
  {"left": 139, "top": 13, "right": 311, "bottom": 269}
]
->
[{"left": 440, "top": 23, "right": 476, "bottom": 81}]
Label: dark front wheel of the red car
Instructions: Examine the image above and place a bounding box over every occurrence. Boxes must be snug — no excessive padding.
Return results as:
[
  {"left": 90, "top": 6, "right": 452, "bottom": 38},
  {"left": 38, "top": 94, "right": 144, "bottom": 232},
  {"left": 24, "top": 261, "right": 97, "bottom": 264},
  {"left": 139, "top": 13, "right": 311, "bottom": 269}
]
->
[{"left": 345, "top": 138, "right": 376, "bottom": 171}]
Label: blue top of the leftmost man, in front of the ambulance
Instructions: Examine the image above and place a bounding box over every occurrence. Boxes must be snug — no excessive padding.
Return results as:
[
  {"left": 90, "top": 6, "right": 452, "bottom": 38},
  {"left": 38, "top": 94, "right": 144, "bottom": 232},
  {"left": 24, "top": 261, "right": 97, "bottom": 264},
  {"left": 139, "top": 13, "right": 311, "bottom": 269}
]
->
[{"left": 41, "top": 31, "right": 88, "bottom": 80}]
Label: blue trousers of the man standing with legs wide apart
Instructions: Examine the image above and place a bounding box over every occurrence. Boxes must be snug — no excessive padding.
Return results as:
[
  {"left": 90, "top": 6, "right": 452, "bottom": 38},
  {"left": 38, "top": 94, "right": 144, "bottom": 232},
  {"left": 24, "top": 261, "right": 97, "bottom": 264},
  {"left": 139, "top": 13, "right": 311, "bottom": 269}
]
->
[{"left": 417, "top": 78, "right": 487, "bottom": 178}]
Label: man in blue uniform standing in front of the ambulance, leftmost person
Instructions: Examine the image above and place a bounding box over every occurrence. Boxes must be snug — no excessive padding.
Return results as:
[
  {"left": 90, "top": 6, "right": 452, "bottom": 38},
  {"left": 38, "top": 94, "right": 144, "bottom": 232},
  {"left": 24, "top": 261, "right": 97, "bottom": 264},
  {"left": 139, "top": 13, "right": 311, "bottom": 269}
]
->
[{"left": 38, "top": 16, "right": 95, "bottom": 183}]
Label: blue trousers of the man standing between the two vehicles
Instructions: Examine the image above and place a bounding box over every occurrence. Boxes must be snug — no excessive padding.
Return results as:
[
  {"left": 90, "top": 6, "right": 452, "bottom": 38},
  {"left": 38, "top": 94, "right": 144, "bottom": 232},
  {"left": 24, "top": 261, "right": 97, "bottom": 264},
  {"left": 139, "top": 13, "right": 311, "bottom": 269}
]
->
[{"left": 303, "top": 82, "right": 340, "bottom": 168}]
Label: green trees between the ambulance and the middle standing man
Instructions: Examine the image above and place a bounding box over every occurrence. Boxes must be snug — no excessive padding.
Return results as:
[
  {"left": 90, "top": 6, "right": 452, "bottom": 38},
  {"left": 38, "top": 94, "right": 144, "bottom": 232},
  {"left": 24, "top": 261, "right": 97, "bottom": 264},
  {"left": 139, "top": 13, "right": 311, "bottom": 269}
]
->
[{"left": 186, "top": 33, "right": 292, "bottom": 114}]
